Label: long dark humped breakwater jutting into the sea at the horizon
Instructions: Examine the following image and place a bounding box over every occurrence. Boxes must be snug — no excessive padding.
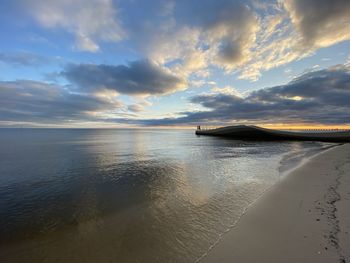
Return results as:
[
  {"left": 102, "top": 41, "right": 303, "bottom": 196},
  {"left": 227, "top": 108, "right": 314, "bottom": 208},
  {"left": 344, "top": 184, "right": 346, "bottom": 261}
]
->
[{"left": 196, "top": 125, "right": 350, "bottom": 142}]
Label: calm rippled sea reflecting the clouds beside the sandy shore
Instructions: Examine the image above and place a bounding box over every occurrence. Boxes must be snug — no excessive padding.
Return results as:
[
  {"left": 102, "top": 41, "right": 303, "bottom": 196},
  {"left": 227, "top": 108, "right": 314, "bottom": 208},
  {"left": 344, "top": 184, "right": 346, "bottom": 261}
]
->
[{"left": 0, "top": 129, "right": 332, "bottom": 262}]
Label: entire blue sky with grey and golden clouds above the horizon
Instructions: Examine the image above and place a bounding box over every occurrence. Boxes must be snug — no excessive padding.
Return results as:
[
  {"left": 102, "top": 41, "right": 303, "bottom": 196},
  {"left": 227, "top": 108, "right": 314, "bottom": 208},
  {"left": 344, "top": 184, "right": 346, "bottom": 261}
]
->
[{"left": 0, "top": 0, "right": 350, "bottom": 127}]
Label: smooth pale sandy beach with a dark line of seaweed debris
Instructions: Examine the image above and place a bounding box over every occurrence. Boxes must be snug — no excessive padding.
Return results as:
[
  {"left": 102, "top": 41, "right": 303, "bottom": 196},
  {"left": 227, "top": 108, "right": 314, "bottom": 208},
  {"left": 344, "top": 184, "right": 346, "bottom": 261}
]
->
[{"left": 199, "top": 144, "right": 350, "bottom": 263}]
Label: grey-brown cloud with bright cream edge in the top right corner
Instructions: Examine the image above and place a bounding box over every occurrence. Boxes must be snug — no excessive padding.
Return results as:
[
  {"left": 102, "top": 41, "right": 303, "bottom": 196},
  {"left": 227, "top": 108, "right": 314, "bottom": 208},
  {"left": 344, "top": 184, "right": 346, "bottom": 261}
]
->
[{"left": 284, "top": 0, "right": 350, "bottom": 48}]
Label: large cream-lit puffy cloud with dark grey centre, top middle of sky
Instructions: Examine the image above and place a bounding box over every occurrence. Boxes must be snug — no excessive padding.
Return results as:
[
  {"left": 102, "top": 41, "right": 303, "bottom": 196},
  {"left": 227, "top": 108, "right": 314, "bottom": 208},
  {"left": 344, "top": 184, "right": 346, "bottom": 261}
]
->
[{"left": 131, "top": 0, "right": 282, "bottom": 80}]
